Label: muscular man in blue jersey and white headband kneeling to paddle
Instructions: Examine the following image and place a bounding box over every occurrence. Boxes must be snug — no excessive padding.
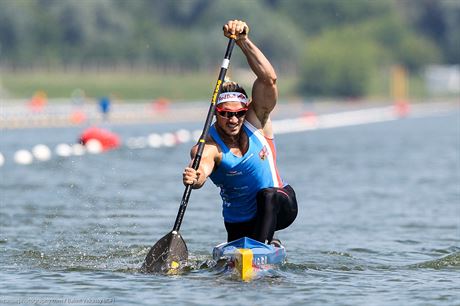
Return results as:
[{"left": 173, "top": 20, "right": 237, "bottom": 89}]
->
[{"left": 183, "top": 20, "right": 297, "bottom": 245}]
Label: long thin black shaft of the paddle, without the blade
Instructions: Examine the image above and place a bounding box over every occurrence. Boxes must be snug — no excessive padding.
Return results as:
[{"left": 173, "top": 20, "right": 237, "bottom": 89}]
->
[{"left": 173, "top": 38, "right": 235, "bottom": 232}]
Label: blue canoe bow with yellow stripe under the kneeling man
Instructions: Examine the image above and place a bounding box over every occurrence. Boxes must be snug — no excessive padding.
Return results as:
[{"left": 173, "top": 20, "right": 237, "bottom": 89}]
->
[{"left": 212, "top": 237, "right": 286, "bottom": 281}]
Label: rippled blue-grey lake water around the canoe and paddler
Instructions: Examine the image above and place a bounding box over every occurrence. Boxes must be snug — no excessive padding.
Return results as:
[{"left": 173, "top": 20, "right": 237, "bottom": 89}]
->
[{"left": 0, "top": 112, "right": 460, "bottom": 305}]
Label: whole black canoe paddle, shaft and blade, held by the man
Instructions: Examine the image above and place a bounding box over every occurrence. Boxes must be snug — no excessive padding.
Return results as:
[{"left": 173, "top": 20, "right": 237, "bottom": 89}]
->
[{"left": 141, "top": 35, "right": 236, "bottom": 273}]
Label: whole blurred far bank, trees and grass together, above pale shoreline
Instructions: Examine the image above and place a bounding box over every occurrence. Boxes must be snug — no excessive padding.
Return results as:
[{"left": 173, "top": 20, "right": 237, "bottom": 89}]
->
[{"left": 0, "top": 0, "right": 460, "bottom": 104}]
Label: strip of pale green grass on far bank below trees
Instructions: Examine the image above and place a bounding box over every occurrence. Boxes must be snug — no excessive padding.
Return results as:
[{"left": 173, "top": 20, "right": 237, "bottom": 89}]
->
[{"left": 0, "top": 70, "right": 296, "bottom": 101}]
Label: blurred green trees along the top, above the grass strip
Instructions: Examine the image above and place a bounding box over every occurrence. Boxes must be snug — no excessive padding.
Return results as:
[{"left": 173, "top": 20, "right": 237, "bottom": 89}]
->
[{"left": 0, "top": 0, "right": 460, "bottom": 96}]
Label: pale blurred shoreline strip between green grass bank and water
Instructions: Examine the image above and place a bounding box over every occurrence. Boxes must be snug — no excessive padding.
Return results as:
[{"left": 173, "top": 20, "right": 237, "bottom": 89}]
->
[{"left": 0, "top": 101, "right": 460, "bottom": 129}]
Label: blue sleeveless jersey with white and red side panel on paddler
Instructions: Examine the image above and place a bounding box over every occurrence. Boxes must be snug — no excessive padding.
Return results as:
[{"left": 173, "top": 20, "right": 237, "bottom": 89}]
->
[{"left": 210, "top": 121, "right": 285, "bottom": 223}]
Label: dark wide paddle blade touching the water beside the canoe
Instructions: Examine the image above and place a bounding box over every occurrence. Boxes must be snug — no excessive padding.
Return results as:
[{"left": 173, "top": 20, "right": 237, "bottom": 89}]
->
[{"left": 141, "top": 231, "right": 188, "bottom": 274}]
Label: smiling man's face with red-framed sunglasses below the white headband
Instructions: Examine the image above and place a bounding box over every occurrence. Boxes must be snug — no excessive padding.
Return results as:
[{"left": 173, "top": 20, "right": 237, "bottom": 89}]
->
[{"left": 216, "top": 102, "right": 248, "bottom": 136}]
